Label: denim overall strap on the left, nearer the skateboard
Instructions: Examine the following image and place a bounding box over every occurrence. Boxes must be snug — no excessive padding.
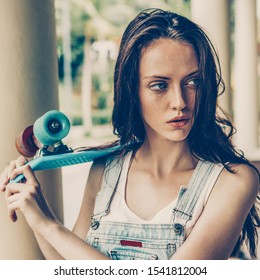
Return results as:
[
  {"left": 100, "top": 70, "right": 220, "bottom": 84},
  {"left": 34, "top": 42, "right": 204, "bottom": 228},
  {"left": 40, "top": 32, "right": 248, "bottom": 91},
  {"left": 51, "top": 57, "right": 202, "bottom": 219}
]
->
[{"left": 91, "top": 156, "right": 125, "bottom": 229}]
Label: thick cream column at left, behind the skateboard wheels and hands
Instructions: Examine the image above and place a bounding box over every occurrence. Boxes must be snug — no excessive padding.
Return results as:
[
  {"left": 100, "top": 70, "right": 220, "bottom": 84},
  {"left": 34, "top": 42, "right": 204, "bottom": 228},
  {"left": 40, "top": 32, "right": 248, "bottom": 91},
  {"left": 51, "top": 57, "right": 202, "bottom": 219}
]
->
[{"left": 0, "top": 0, "right": 63, "bottom": 260}]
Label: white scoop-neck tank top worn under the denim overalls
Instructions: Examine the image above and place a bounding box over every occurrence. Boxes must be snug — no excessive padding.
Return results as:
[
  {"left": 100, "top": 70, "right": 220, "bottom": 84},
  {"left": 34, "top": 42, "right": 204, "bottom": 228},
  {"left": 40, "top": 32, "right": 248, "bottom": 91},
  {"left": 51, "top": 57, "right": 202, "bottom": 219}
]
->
[{"left": 102, "top": 152, "right": 223, "bottom": 234}]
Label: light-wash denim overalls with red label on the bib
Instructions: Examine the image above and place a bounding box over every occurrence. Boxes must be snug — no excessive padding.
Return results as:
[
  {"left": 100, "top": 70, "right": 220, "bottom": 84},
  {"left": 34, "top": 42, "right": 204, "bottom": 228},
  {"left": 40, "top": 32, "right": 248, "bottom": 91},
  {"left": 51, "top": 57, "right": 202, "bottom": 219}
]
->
[{"left": 86, "top": 154, "right": 220, "bottom": 260}]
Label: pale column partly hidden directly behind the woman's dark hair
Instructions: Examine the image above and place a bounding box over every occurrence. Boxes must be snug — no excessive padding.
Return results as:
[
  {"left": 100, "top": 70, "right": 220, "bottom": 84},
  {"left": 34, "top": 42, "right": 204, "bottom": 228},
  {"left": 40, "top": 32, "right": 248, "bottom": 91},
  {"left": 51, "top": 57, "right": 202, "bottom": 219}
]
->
[{"left": 191, "top": 0, "right": 231, "bottom": 113}]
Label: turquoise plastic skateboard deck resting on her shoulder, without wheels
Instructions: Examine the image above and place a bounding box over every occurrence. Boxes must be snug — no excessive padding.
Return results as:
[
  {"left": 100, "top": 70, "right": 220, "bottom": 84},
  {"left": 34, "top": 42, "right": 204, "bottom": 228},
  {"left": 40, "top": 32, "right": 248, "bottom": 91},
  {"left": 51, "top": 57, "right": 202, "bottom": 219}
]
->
[{"left": 11, "top": 145, "right": 122, "bottom": 183}]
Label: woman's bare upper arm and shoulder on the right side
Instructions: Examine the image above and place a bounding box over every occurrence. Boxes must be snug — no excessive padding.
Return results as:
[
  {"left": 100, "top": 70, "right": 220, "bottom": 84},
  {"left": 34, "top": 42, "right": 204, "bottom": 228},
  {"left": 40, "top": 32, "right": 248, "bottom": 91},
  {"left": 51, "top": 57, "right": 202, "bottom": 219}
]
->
[{"left": 172, "top": 165, "right": 259, "bottom": 260}]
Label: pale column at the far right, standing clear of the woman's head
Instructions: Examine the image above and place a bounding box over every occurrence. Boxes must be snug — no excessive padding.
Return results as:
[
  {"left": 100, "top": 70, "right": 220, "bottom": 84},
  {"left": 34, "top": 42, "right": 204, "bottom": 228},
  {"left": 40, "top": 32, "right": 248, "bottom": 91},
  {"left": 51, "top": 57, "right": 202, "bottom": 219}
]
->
[{"left": 234, "top": 0, "right": 259, "bottom": 154}]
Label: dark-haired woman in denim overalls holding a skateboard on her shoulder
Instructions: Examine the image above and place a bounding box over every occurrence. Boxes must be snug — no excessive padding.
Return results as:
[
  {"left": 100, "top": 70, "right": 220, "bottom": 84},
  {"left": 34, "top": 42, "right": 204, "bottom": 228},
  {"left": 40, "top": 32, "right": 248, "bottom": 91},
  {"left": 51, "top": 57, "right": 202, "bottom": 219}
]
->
[{"left": 2, "top": 9, "right": 260, "bottom": 259}]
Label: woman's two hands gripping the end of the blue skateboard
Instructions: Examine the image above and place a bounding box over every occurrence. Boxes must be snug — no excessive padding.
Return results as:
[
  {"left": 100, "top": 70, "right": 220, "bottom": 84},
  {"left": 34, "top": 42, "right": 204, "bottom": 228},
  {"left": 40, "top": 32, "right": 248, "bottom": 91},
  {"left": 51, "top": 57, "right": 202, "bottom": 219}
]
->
[{"left": 1, "top": 157, "right": 55, "bottom": 233}]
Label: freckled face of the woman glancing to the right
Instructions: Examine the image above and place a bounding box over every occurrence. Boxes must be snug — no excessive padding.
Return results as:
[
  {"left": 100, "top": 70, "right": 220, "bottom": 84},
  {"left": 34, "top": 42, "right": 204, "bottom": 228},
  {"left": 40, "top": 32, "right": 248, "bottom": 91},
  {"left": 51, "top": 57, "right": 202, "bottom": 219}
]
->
[{"left": 139, "top": 38, "right": 198, "bottom": 141}]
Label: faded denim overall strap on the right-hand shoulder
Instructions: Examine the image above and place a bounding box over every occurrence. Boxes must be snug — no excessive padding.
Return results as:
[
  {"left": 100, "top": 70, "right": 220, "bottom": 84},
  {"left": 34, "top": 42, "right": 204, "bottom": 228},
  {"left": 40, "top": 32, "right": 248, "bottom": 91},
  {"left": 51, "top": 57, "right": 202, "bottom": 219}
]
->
[{"left": 173, "top": 160, "right": 217, "bottom": 226}]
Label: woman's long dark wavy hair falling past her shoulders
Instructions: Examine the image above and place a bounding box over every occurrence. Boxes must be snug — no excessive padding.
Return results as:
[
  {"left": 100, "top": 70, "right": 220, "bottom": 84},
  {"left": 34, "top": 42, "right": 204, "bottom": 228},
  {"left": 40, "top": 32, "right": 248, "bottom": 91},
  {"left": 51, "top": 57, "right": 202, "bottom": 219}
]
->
[{"left": 109, "top": 9, "right": 260, "bottom": 258}]
